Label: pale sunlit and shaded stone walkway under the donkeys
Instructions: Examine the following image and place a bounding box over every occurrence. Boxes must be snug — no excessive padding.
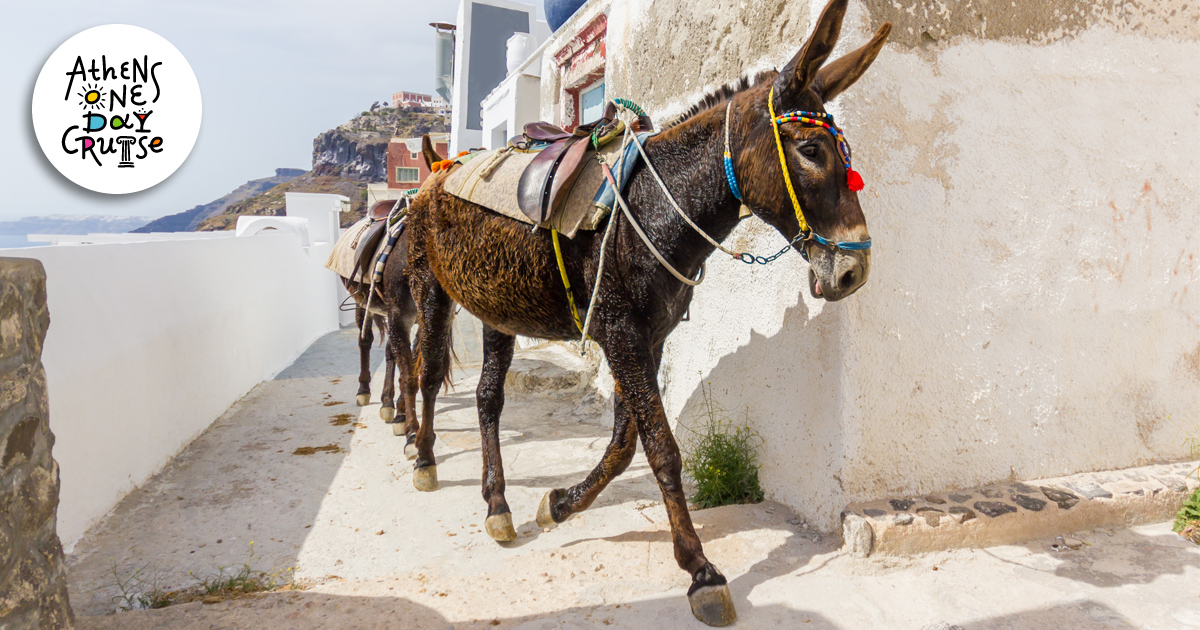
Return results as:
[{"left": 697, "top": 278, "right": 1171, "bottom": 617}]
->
[{"left": 67, "top": 331, "right": 1200, "bottom": 630}]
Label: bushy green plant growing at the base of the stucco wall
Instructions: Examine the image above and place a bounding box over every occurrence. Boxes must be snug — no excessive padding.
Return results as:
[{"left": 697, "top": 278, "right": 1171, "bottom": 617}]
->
[{"left": 683, "top": 384, "right": 762, "bottom": 508}]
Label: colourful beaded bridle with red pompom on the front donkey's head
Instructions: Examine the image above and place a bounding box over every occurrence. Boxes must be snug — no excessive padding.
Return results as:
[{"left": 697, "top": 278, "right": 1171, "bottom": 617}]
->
[{"left": 725, "top": 85, "right": 871, "bottom": 264}]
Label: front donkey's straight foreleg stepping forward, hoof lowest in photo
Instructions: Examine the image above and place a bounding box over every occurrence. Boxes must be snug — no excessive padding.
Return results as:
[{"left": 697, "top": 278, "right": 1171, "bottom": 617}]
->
[{"left": 605, "top": 332, "right": 737, "bottom": 625}]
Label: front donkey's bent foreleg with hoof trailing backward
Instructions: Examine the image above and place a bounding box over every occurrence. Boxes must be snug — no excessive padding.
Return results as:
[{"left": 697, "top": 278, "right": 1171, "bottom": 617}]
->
[{"left": 538, "top": 392, "right": 637, "bottom": 527}]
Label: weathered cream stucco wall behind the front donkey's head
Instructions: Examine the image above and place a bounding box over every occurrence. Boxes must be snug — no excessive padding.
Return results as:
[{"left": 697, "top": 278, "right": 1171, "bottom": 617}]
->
[{"left": 542, "top": 0, "right": 1200, "bottom": 529}]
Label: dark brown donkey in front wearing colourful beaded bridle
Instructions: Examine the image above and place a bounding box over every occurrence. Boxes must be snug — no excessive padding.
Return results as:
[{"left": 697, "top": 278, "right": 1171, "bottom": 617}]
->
[{"left": 408, "top": 0, "right": 890, "bottom": 625}]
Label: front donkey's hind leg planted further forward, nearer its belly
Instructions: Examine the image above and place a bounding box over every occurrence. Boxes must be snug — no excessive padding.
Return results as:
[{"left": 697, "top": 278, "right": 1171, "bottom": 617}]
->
[{"left": 475, "top": 325, "right": 517, "bottom": 542}]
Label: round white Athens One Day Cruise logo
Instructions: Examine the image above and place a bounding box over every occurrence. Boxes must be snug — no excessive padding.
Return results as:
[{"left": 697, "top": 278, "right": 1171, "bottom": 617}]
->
[{"left": 34, "top": 24, "right": 200, "bottom": 194}]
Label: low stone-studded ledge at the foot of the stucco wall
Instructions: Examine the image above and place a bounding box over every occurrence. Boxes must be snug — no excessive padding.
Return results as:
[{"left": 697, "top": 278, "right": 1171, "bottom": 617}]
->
[{"left": 842, "top": 462, "right": 1200, "bottom": 556}]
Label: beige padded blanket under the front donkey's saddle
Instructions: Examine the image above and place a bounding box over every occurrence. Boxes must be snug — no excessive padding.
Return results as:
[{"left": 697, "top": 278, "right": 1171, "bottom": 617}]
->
[{"left": 443, "top": 132, "right": 650, "bottom": 239}]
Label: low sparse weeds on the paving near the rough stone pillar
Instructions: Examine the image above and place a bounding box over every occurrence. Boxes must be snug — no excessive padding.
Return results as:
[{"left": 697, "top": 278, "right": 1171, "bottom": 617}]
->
[{"left": 113, "top": 542, "right": 295, "bottom": 611}]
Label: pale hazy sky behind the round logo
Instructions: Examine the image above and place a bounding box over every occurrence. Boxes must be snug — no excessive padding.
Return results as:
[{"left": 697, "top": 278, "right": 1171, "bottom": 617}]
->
[{"left": 0, "top": 0, "right": 472, "bottom": 221}]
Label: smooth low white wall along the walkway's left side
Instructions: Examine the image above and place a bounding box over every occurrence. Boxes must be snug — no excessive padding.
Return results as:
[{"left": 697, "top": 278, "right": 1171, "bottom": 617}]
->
[{"left": 5, "top": 233, "right": 337, "bottom": 550}]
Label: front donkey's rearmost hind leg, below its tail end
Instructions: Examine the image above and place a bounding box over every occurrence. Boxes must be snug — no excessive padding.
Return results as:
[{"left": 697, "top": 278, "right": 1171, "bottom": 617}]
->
[{"left": 413, "top": 284, "right": 454, "bottom": 492}]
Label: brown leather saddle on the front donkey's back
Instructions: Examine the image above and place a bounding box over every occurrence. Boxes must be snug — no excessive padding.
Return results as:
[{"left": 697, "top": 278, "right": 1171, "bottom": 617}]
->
[{"left": 509, "top": 103, "right": 652, "bottom": 224}]
